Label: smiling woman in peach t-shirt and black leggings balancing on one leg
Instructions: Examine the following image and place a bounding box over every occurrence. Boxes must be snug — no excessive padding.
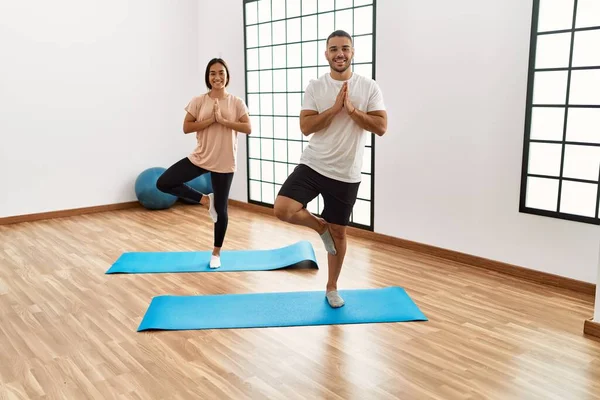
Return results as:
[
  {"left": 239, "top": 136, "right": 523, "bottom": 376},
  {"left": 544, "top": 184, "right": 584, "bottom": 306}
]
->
[{"left": 156, "top": 58, "right": 251, "bottom": 268}]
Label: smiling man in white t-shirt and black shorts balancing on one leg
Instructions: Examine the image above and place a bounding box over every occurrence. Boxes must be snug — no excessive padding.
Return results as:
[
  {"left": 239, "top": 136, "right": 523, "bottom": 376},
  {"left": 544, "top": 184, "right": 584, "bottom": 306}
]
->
[{"left": 275, "top": 30, "right": 387, "bottom": 308}]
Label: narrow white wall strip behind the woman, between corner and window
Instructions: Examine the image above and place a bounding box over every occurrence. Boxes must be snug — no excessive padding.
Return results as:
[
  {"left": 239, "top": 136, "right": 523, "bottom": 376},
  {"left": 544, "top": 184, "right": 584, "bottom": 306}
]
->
[{"left": 198, "top": 0, "right": 248, "bottom": 202}]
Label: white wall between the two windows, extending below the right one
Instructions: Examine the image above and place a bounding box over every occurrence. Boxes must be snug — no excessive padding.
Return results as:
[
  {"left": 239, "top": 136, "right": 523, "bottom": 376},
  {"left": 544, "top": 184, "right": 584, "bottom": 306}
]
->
[{"left": 375, "top": 0, "right": 599, "bottom": 282}]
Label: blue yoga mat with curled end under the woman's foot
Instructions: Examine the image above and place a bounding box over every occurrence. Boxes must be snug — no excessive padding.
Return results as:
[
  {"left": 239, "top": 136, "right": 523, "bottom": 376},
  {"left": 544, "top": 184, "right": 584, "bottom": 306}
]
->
[{"left": 106, "top": 241, "right": 318, "bottom": 274}]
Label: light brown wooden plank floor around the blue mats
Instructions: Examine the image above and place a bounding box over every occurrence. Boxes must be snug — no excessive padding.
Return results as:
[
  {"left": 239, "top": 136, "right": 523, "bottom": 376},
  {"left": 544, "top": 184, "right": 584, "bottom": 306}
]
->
[{"left": 0, "top": 206, "right": 600, "bottom": 400}]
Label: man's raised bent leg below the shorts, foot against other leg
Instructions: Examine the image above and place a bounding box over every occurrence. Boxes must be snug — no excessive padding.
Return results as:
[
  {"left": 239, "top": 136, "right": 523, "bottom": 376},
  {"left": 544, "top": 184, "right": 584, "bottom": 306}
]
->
[{"left": 274, "top": 196, "right": 337, "bottom": 255}]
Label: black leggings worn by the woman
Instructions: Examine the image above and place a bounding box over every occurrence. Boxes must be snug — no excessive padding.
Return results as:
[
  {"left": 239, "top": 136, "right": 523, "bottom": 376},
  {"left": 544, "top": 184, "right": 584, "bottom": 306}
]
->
[{"left": 156, "top": 157, "right": 233, "bottom": 247}]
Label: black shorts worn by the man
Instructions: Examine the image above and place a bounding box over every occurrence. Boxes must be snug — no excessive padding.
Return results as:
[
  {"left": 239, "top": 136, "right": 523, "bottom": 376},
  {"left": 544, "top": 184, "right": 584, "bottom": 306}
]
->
[{"left": 279, "top": 164, "right": 360, "bottom": 226}]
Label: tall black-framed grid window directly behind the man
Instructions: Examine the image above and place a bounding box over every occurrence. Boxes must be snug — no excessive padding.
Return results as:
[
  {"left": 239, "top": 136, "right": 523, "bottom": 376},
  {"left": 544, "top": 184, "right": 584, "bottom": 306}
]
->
[{"left": 244, "top": 0, "right": 375, "bottom": 230}]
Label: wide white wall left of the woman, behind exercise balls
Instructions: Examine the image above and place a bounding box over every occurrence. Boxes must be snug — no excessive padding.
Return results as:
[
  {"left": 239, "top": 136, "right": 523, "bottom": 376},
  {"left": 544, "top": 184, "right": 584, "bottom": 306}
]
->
[{"left": 0, "top": 0, "right": 203, "bottom": 217}]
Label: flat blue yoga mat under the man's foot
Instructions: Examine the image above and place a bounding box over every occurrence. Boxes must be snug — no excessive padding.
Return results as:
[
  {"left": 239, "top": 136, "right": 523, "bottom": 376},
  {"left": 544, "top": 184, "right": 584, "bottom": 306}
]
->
[{"left": 138, "top": 287, "right": 427, "bottom": 332}]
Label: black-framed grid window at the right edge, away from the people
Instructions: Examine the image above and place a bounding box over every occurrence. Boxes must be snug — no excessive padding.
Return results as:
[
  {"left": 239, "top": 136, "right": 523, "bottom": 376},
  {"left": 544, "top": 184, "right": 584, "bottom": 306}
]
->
[{"left": 520, "top": 0, "right": 600, "bottom": 224}]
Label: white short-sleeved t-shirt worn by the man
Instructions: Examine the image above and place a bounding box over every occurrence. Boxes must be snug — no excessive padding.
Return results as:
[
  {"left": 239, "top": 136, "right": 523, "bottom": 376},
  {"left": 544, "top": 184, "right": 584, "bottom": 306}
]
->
[{"left": 300, "top": 73, "right": 385, "bottom": 183}]
